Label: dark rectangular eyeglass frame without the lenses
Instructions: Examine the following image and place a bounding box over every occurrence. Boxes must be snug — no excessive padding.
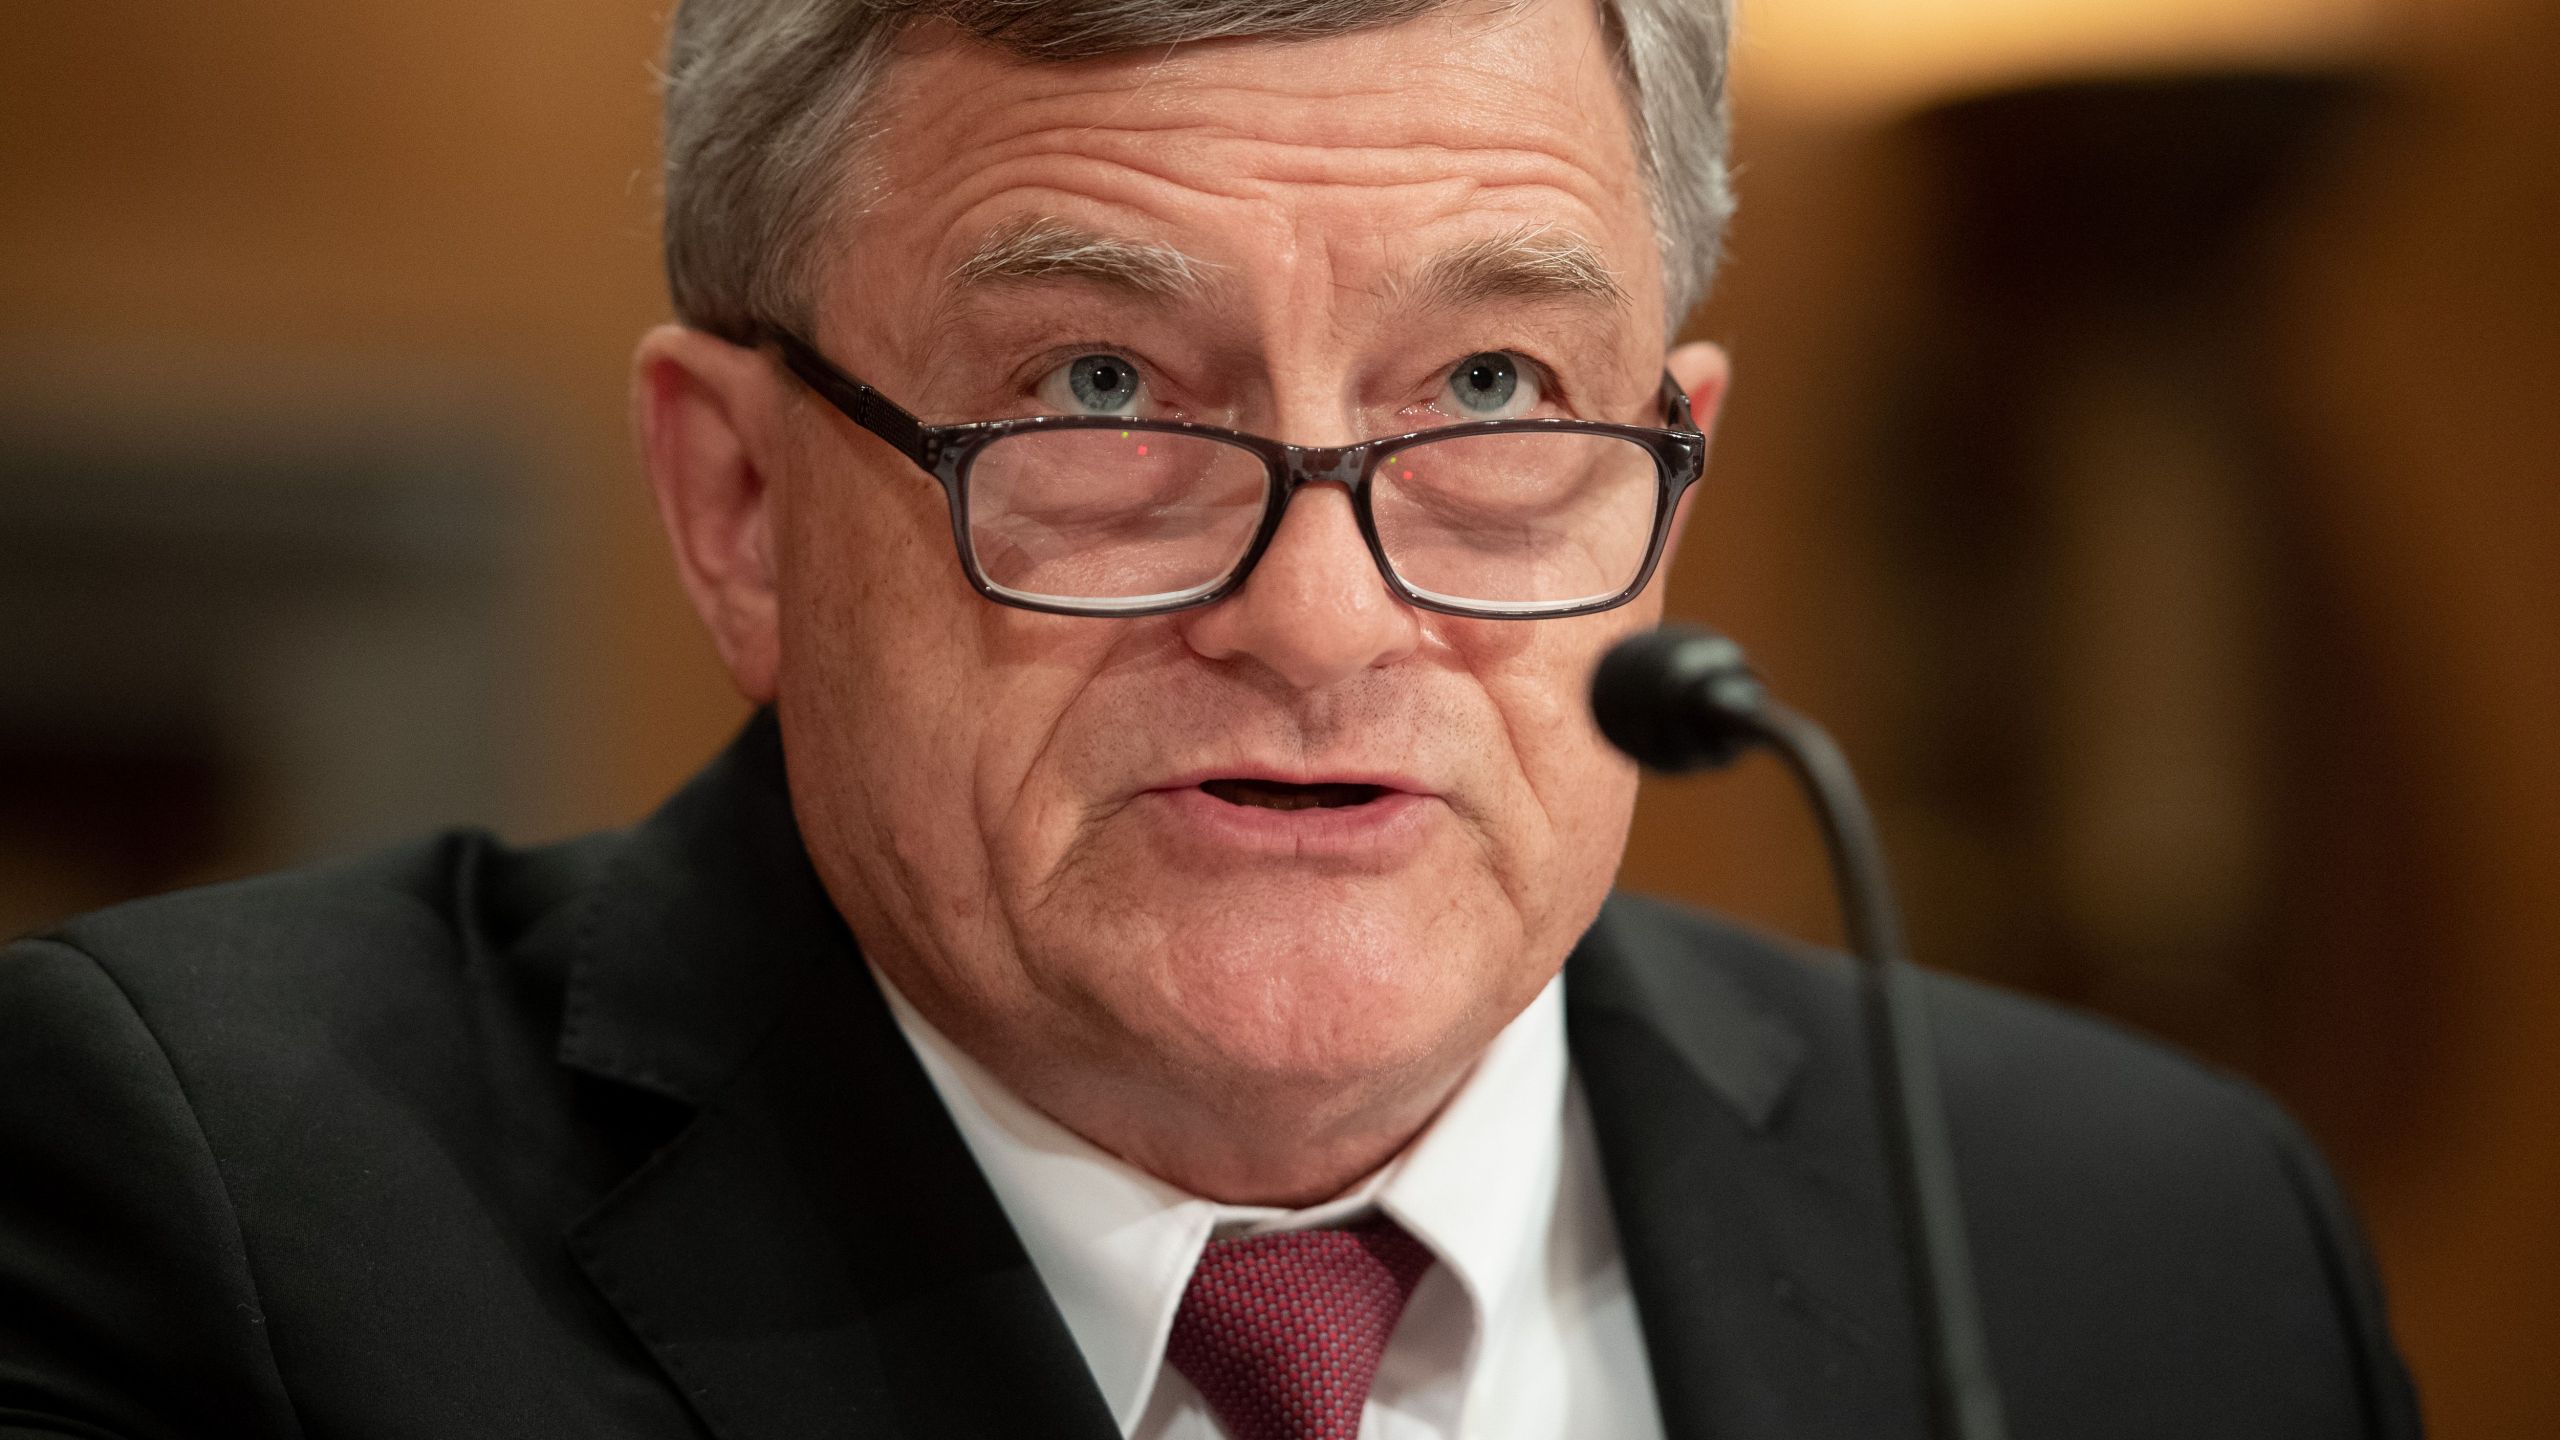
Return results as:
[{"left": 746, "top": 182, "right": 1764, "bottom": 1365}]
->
[{"left": 763, "top": 325, "right": 1708, "bottom": 620}]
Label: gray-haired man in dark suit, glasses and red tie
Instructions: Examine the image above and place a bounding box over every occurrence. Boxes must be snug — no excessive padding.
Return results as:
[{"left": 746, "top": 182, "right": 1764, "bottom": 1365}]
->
[{"left": 0, "top": 0, "right": 2414, "bottom": 1440}]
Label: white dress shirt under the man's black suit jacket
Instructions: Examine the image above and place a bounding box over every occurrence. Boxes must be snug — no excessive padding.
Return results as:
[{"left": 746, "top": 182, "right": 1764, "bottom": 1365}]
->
[{"left": 881, "top": 976, "right": 1661, "bottom": 1440}]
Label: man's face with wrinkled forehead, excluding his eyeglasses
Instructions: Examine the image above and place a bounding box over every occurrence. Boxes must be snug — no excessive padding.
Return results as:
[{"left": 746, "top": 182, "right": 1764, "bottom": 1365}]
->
[{"left": 773, "top": 0, "right": 1720, "bottom": 1158}]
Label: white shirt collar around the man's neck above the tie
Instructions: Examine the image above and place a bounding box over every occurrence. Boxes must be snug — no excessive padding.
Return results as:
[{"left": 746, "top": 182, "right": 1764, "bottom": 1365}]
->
[{"left": 876, "top": 971, "right": 1567, "bottom": 1432}]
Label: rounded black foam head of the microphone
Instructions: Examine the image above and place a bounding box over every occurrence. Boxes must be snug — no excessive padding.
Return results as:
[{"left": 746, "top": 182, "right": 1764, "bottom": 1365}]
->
[{"left": 1592, "top": 625, "right": 1769, "bottom": 774}]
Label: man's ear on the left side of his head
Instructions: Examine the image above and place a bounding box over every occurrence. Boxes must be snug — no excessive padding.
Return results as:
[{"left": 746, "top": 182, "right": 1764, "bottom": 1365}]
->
[{"left": 632, "top": 325, "right": 781, "bottom": 705}]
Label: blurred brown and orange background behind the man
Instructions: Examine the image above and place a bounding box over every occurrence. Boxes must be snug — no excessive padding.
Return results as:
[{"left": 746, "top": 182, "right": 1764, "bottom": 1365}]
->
[{"left": 0, "top": 0, "right": 2560, "bottom": 1440}]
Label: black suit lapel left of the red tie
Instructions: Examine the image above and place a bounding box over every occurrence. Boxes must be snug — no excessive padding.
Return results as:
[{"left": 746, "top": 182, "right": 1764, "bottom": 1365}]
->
[{"left": 561, "top": 717, "right": 1116, "bottom": 1440}]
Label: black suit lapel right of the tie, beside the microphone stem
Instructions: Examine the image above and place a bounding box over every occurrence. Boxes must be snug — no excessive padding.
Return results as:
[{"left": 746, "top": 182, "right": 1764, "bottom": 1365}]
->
[{"left": 1564, "top": 902, "right": 1923, "bottom": 1440}]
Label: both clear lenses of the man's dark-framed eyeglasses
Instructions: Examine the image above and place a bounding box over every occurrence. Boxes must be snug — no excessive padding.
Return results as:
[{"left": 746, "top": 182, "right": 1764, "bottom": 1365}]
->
[{"left": 965, "top": 428, "right": 1659, "bottom": 610}]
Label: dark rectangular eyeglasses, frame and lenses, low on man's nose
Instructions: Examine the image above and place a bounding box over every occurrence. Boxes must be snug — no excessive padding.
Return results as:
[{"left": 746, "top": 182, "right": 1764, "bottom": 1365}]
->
[{"left": 765, "top": 328, "right": 1708, "bottom": 620}]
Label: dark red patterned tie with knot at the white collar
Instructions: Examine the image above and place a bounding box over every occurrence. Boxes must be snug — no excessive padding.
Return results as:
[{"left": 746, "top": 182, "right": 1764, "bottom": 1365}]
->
[{"left": 1165, "top": 1215, "right": 1431, "bottom": 1440}]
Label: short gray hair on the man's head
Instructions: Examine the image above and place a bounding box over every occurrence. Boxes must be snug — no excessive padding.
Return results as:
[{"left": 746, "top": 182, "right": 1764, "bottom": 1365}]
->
[{"left": 666, "top": 0, "right": 1733, "bottom": 341}]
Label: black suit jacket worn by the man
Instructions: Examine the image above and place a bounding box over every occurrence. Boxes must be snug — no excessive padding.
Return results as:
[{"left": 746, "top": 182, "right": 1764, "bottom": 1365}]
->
[{"left": 0, "top": 720, "right": 2417, "bottom": 1440}]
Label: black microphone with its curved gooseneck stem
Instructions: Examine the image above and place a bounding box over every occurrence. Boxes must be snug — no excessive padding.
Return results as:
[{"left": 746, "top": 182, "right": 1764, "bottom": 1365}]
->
[{"left": 1592, "top": 625, "right": 2007, "bottom": 1440}]
